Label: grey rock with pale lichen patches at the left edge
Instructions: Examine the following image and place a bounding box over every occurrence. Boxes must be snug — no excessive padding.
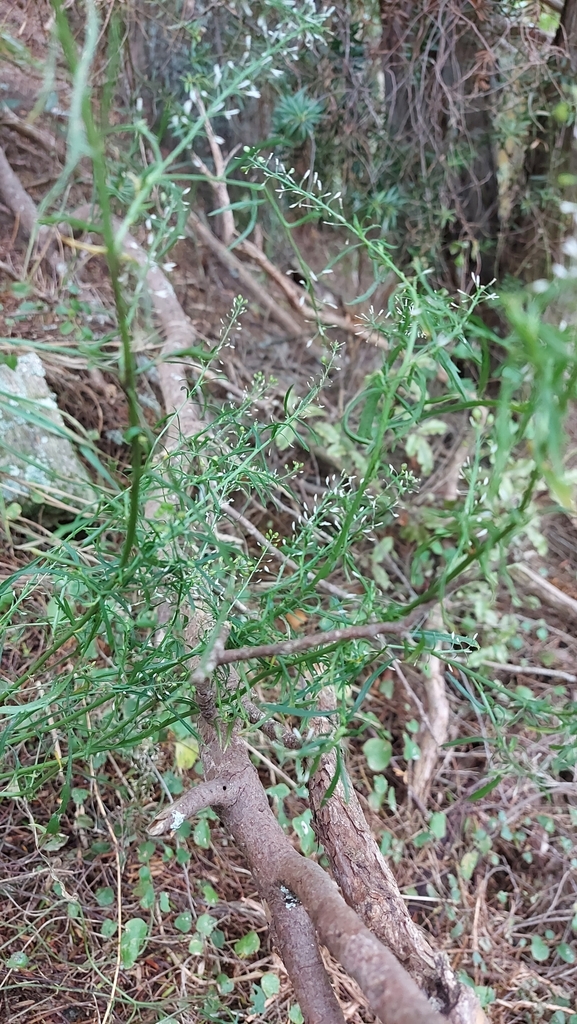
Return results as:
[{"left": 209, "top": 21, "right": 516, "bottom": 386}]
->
[{"left": 0, "top": 352, "right": 96, "bottom": 514}]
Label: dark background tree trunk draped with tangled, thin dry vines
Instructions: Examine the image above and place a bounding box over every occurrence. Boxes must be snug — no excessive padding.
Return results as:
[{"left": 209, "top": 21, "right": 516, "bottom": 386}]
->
[{"left": 380, "top": 0, "right": 499, "bottom": 287}]
